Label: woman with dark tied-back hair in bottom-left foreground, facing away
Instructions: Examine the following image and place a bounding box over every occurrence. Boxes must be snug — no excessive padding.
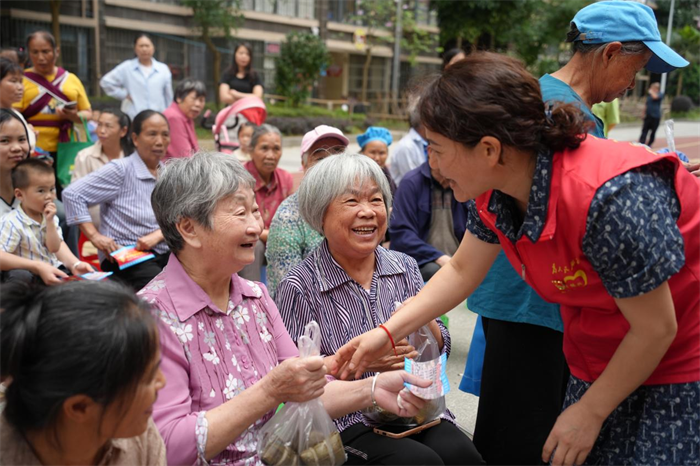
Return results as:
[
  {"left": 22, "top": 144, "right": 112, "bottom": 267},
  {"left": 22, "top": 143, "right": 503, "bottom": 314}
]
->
[{"left": 0, "top": 281, "right": 166, "bottom": 466}]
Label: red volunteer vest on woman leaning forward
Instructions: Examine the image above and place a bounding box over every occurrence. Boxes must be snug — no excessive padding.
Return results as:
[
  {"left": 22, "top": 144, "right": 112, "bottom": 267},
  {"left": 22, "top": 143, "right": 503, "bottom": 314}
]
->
[{"left": 476, "top": 135, "right": 700, "bottom": 385}]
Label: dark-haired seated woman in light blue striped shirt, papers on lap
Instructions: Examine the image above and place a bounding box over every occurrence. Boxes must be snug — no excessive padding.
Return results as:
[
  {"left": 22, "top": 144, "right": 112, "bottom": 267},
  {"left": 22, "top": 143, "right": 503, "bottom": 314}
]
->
[{"left": 63, "top": 110, "right": 170, "bottom": 291}]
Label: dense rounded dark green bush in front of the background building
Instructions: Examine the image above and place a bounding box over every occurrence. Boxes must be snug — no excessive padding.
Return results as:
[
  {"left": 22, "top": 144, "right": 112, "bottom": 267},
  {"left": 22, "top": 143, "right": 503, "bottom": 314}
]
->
[{"left": 275, "top": 32, "right": 330, "bottom": 107}]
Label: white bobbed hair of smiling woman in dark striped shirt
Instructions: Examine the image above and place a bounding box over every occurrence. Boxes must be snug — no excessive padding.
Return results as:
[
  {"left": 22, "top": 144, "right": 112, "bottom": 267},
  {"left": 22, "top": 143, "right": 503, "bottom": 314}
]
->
[{"left": 299, "top": 153, "right": 391, "bottom": 234}]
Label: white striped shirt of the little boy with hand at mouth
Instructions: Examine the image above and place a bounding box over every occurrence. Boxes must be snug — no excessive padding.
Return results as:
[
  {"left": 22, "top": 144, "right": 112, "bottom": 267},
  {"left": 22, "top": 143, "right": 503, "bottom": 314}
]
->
[{"left": 0, "top": 206, "right": 63, "bottom": 267}]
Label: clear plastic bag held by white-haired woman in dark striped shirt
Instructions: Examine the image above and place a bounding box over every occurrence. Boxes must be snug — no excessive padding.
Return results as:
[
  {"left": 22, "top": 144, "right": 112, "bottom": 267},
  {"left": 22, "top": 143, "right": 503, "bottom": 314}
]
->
[{"left": 363, "top": 325, "right": 447, "bottom": 426}]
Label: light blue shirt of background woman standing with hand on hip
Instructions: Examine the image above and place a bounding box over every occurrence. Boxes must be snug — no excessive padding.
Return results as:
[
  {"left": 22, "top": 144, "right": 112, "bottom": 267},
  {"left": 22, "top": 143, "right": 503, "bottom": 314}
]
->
[{"left": 100, "top": 58, "right": 173, "bottom": 120}]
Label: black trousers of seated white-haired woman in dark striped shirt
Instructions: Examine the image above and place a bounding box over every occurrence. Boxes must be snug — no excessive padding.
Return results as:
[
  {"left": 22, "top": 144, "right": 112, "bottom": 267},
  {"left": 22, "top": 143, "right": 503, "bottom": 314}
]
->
[{"left": 340, "top": 420, "right": 486, "bottom": 466}]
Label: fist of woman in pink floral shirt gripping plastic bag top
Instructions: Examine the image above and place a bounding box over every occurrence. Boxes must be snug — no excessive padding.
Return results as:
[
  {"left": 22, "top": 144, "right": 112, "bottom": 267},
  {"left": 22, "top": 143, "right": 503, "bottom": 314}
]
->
[{"left": 260, "top": 356, "right": 327, "bottom": 403}]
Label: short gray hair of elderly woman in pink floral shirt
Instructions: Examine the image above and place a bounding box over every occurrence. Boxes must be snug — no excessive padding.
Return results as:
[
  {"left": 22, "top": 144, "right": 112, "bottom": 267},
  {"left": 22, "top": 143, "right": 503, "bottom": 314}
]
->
[{"left": 151, "top": 151, "right": 255, "bottom": 253}]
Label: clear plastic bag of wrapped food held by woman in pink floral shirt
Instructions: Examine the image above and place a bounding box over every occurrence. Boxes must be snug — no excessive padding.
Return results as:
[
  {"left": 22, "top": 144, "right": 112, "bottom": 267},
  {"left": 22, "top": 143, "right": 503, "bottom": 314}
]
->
[{"left": 258, "top": 321, "right": 347, "bottom": 466}]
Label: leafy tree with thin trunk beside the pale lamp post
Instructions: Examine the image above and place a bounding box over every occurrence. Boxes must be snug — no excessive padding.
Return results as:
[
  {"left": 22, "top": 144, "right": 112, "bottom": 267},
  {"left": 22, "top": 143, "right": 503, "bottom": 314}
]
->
[{"left": 350, "top": 0, "right": 436, "bottom": 102}]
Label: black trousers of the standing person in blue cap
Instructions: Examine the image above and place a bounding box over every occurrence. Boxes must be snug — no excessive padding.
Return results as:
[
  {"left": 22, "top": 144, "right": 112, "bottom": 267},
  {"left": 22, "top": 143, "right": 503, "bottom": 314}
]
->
[{"left": 474, "top": 316, "right": 569, "bottom": 466}]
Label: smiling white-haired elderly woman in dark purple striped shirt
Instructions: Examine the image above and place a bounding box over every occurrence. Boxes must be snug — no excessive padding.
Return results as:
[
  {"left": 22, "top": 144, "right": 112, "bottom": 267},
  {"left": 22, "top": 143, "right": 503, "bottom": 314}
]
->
[{"left": 276, "top": 154, "right": 485, "bottom": 466}]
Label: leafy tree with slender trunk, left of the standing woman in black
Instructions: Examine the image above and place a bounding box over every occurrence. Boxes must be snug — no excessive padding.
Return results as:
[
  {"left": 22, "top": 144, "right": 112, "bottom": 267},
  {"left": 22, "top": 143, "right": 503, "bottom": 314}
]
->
[{"left": 181, "top": 0, "right": 243, "bottom": 104}]
